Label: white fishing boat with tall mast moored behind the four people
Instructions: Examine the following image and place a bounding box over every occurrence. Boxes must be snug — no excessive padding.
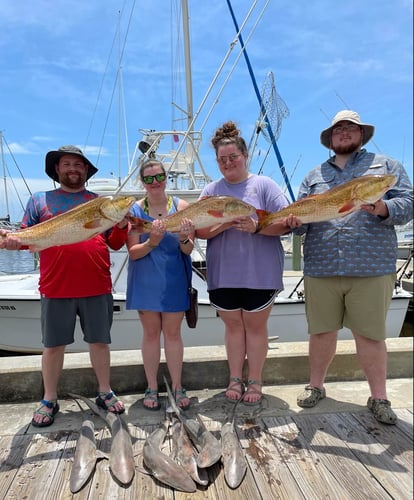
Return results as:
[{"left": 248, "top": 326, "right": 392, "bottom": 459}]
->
[{"left": 0, "top": 0, "right": 412, "bottom": 354}]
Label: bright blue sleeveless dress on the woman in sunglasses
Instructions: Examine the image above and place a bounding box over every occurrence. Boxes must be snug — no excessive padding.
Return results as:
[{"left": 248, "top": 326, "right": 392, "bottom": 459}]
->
[{"left": 126, "top": 197, "right": 191, "bottom": 312}]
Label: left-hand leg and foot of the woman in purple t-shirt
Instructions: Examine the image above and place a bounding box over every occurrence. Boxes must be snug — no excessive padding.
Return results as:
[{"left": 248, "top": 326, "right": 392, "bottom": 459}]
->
[{"left": 219, "top": 310, "right": 246, "bottom": 400}]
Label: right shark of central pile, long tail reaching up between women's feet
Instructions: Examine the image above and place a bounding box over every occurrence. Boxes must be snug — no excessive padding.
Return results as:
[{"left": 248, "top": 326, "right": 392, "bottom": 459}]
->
[{"left": 164, "top": 377, "right": 221, "bottom": 469}]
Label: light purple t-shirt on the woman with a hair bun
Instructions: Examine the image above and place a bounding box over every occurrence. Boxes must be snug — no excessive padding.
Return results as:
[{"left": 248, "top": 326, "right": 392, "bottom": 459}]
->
[{"left": 201, "top": 174, "right": 289, "bottom": 290}]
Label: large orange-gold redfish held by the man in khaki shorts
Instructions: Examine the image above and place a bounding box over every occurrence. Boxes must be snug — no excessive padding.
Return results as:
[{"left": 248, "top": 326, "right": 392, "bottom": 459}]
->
[{"left": 257, "top": 174, "right": 396, "bottom": 230}]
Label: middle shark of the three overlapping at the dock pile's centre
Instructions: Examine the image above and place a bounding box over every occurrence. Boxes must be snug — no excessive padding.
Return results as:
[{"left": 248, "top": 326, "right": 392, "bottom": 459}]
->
[{"left": 171, "top": 416, "right": 208, "bottom": 486}]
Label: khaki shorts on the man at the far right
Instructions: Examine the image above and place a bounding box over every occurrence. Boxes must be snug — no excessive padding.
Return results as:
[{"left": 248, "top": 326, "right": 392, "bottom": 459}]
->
[{"left": 304, "top": 274, "right": 396, "bottom": 340}]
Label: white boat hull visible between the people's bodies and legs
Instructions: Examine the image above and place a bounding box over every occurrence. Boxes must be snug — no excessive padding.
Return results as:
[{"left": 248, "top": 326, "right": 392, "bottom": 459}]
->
[{"left": 0, "top": 266, "right": 412, "bottom": 353}]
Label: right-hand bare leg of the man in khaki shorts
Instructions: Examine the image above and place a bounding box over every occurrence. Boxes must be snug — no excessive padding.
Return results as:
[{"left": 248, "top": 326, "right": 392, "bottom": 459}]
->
[{"left": 352, "top": 332, "right": 388, "bottom": 399}]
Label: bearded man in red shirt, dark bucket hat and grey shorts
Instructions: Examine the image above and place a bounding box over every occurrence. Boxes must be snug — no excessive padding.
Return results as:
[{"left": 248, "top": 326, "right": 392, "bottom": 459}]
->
[{"left": 2, "top": 146, "right": 128, "bottom": 427}]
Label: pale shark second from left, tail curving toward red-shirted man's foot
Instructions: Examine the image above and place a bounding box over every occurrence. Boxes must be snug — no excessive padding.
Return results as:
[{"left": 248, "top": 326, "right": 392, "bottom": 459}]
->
[{"left": 68, "top": 393, "right": 135, "bottom": 485}]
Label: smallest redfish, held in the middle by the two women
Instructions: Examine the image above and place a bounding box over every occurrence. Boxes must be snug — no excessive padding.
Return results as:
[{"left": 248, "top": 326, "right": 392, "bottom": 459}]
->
[{"left": 130, "top": 196, "right": 256, "bottom": 233}]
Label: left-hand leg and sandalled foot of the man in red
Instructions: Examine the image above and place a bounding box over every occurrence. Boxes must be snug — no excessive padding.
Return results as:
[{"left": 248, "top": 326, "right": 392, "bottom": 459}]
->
[{"left": 33, "top": 346, "right": 66, "bottom": 424}]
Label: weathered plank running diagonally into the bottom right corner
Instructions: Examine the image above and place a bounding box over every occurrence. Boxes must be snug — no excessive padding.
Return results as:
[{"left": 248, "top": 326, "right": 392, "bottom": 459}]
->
[{"left": 326, "top": 414, "right": 413, "bottom": 498}]
